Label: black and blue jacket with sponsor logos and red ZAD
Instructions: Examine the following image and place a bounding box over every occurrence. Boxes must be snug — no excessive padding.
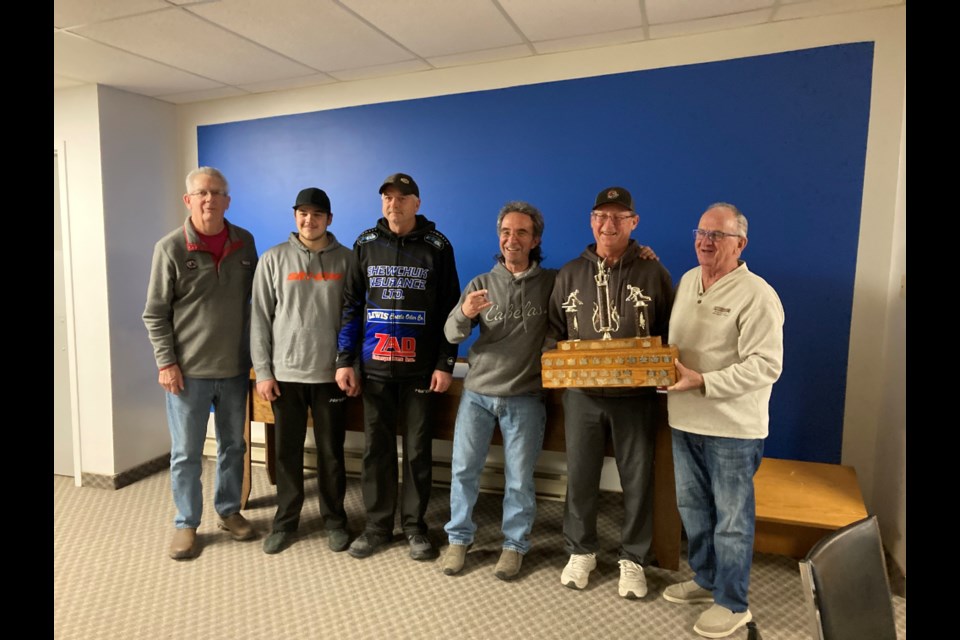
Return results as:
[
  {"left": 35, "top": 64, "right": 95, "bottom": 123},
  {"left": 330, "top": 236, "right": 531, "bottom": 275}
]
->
[{"left": 337, "top": 215, "right": 460, "bottom": 380}]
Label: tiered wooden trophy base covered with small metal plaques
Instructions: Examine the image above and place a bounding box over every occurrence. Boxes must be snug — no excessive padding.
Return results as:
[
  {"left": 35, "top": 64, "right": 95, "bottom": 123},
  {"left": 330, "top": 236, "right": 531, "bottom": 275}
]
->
[{"left": 540, "top": 336, "right": 679, "bottom": 389}]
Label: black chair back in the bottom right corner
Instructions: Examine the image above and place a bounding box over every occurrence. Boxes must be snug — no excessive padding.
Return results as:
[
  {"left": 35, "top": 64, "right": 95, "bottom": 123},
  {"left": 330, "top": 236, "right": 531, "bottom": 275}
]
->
[{"left": 800, "top": 516, "right": 897, "bottom": 640}]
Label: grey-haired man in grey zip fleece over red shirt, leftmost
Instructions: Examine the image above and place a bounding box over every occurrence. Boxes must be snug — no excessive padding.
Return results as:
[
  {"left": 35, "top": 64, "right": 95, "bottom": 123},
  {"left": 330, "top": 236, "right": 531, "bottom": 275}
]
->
[{"left": 143, "top": 167, "right": 257, "bottom": 560}]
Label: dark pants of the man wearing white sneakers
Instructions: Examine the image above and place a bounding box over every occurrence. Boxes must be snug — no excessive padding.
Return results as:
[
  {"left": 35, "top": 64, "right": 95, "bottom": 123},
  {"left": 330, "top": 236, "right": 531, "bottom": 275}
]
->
[{"left": 563, "top": 389, "right": 656, "bottom": 565}]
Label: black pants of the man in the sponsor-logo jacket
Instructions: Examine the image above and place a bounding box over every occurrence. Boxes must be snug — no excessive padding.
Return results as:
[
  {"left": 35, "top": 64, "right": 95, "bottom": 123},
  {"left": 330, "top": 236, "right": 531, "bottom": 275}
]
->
[{"left": 361, "top": 378, "right": 433, "bottom": 535}]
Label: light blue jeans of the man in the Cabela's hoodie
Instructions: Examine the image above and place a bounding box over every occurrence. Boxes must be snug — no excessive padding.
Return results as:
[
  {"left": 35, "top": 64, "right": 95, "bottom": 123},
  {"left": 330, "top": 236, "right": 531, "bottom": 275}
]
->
[{"left": 444, "top": 389, "right": 547, "bottom": 554}]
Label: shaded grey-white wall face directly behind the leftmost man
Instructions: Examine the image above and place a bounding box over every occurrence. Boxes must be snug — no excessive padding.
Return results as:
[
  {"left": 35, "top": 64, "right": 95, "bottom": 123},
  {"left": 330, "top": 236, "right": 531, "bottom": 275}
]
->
[{"left": 99, "top": 87, "right": 180, "bottom": 473}]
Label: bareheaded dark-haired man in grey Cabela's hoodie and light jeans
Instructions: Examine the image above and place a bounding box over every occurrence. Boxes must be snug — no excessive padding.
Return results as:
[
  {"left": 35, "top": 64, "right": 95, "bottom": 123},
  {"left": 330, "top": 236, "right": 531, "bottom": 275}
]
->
[{"left": 442, "top": 202, "right": 556, "bottom": 580}]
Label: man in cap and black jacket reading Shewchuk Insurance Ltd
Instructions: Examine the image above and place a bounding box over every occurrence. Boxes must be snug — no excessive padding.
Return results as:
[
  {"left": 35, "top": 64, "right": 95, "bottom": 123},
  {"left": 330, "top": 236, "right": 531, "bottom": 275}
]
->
[{"left": 336, "top": 173, "right": 460, "bottom": 560}]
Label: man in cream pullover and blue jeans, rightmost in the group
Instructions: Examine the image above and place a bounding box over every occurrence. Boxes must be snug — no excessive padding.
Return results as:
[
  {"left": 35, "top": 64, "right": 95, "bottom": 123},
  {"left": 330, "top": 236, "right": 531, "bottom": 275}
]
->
[{"left": 663, "top": 203, "right": 783, "bottom": 638}]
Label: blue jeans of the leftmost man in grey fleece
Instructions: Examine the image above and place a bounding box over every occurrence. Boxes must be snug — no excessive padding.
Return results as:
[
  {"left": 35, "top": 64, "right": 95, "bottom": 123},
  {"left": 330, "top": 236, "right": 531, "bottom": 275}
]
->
[{"left": 167, "top": 373, "right": 248, "bottom": 529}]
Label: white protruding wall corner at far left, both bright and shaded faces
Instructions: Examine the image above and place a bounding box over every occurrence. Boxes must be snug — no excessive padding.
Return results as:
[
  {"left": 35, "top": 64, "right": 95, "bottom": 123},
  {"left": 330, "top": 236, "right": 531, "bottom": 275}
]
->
[{"left": 54, "top": 85, "right": 183, "bottom": 476}]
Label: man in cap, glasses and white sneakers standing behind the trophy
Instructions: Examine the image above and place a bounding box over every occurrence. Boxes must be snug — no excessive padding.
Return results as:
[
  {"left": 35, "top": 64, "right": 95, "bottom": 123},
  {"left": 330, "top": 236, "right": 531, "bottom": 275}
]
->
[{"left": 544, "top": 187, "right": 673, "bottom": 599}]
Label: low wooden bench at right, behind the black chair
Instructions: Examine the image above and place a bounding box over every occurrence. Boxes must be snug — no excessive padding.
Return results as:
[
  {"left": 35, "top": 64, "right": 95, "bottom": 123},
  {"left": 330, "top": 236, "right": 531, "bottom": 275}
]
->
[{"left": 753, "top": 458, "right": 867, "bottom": 558}]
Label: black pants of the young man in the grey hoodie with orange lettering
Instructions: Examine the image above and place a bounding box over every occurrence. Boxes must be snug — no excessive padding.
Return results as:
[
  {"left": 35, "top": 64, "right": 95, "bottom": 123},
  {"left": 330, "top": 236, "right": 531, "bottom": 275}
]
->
[{"left": 273, "top": 381, "right": 347, "bottom": 531}]
